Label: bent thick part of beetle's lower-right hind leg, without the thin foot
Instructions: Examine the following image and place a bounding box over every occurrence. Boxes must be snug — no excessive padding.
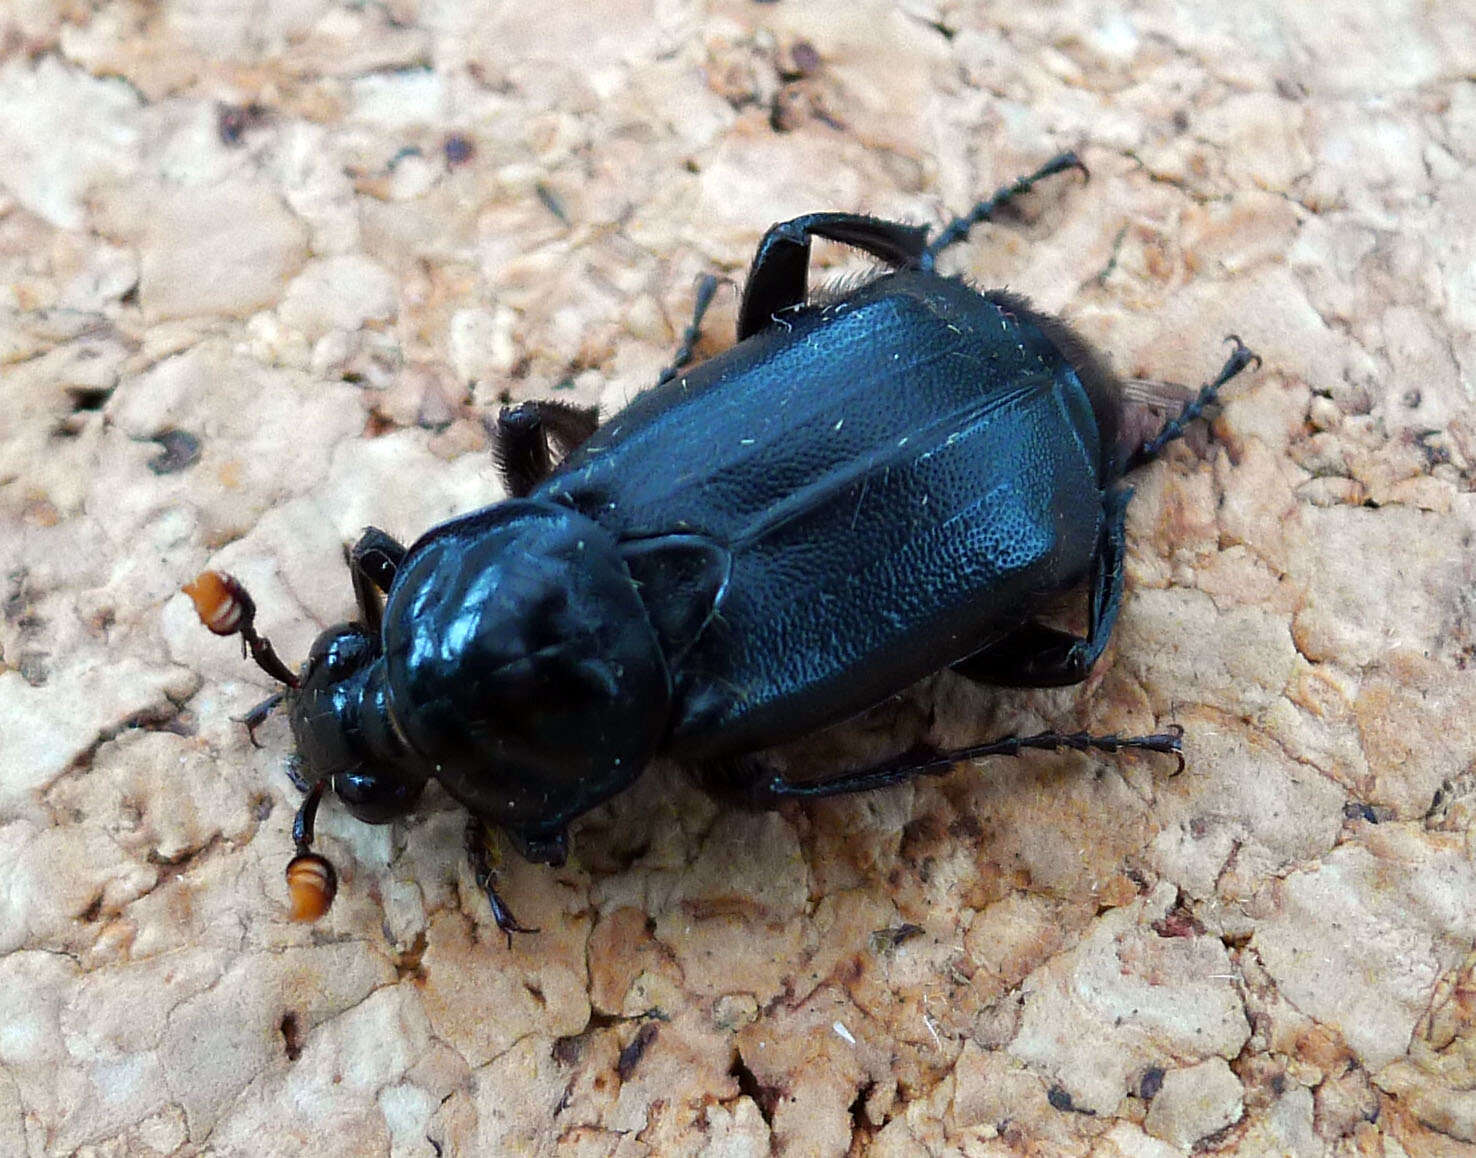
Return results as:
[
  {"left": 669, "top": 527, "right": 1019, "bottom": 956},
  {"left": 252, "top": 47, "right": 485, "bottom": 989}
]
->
[{"left": 953, "top": 487, "right": 1132, "bottom": 687}]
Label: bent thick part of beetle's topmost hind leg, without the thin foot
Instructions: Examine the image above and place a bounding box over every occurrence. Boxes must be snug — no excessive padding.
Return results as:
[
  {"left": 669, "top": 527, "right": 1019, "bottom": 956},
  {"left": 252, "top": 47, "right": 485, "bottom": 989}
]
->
[{"left": 738, "top": 212, "right": 927, "bottom": 342}]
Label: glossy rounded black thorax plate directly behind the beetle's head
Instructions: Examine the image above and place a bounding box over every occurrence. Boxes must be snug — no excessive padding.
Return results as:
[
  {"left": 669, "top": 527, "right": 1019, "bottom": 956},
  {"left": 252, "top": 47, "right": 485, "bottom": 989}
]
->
[{"left": 371, "top": 500, "right": 670, "bottom": 826}]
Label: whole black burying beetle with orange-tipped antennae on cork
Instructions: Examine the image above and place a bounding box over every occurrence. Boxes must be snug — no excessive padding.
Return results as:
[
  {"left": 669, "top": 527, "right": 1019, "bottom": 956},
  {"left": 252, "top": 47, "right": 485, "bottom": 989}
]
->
[{"left": 186, "top": 153, "right": 1256, "bottom": 943}]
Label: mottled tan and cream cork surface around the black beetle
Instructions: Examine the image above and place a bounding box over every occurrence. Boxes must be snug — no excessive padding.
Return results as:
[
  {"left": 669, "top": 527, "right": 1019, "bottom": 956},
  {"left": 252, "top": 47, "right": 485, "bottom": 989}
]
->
[{"left": 0, "top": 0, "right": 1476, "bottom": 1158}]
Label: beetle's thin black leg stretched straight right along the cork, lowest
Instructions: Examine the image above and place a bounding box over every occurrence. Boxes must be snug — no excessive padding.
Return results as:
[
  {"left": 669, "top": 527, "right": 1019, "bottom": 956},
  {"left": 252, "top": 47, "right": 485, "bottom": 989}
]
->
[{"left": 698, "top": 727, "right": 1184, "bottom": 808}]
